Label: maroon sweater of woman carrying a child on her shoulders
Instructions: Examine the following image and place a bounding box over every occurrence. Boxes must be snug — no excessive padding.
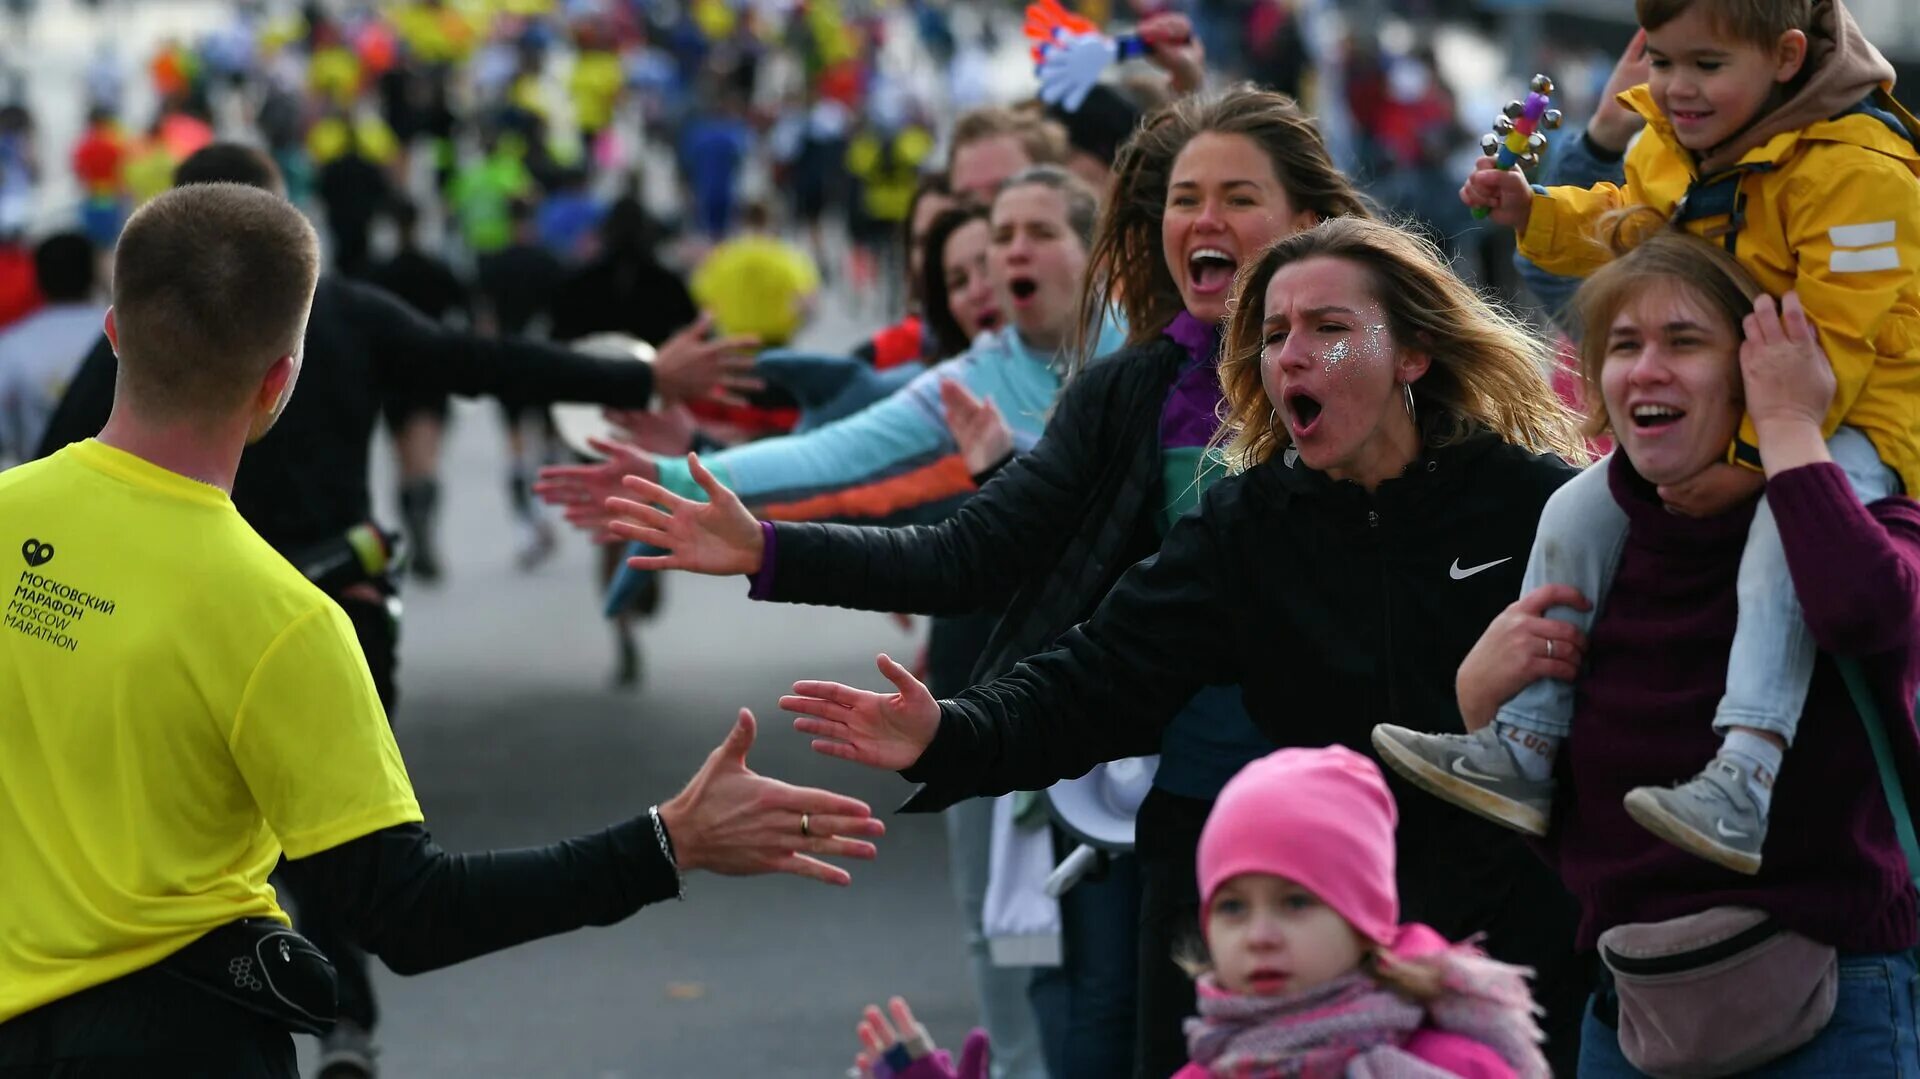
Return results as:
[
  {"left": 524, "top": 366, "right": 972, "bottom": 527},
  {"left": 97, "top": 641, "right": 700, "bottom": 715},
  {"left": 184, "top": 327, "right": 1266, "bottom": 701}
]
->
[{"left": 1548, "top": 453, "right": 1920, "bottom": 952}]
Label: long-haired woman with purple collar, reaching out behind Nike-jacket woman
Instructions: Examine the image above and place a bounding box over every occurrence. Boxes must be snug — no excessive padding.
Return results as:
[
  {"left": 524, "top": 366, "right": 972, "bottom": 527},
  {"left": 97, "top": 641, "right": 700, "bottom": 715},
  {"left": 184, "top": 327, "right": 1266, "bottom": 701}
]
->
[{"left": 606, "top": 86, "right": 1367, "bottom": 1079}]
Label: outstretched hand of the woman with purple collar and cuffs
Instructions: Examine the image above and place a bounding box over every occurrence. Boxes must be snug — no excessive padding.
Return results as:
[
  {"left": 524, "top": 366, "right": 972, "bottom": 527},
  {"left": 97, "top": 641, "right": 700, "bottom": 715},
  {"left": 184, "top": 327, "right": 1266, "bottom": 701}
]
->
[{"left": 607, "top": 453, "right": 766, "bottom": 576}]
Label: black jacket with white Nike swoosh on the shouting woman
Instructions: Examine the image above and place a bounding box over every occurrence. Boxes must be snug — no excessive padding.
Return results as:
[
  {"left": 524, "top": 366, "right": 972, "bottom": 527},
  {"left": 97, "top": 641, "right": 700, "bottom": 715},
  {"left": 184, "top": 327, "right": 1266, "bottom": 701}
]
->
[{"left": 906, "top": 434, "right": 1572, "bottom": 962}]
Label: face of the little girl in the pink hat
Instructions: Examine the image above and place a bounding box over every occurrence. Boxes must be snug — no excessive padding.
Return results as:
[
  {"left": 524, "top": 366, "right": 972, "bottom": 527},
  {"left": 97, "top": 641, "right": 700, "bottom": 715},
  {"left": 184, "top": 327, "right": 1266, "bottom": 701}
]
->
[{"left": 1206, "top": 874, "right": 1369, "bottom": 996}]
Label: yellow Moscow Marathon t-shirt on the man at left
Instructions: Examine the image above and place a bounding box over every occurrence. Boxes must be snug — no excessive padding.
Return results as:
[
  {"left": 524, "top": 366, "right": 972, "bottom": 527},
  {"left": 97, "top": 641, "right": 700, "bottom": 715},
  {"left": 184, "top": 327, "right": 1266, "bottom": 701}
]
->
[{"left": 0, "top": 442, "right": 420, "bottom": 1021}]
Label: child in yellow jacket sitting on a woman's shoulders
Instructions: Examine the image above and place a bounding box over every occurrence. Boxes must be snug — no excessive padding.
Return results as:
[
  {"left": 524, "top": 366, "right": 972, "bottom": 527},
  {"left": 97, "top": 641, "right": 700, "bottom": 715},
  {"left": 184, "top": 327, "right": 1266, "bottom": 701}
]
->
[{"left": 1375, "top": 0, "right": 1920, "bottom": 874}]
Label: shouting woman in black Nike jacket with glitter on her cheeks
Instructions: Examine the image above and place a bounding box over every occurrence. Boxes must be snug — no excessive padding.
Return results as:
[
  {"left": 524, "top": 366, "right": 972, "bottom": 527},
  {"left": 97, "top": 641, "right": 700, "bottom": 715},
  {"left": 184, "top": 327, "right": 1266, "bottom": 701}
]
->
[{"left": 780, "top": 219, "right": 1586, "bottom": 1060}]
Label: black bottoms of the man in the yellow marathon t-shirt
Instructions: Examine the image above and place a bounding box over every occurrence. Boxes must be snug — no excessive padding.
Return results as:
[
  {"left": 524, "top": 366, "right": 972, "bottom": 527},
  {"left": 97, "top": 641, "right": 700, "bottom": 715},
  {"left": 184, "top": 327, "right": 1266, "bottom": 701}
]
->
[{"left": 0, "top": 968, "right": 300, "bottom": 1079}]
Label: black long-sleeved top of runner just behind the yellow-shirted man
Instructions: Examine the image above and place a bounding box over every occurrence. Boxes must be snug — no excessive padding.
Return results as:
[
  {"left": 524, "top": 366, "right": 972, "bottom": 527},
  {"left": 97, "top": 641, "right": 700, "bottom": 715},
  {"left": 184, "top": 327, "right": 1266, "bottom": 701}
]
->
[{"left": 38, "top": 276, "right": 653, "bottom": 553}]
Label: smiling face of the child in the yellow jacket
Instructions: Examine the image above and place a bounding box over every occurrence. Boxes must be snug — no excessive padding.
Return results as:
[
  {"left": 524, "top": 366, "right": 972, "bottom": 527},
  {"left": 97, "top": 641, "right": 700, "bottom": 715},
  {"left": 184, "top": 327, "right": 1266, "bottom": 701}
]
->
[{"left": 1647, "top": 4, "right": 1807, "bottom": 152}]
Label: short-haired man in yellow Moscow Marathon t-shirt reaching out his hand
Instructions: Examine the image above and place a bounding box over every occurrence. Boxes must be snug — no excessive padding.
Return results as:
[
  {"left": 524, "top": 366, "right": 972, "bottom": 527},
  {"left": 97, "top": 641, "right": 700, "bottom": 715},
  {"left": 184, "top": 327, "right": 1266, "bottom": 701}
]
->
[{"left": 0, "top": 184, "right": 881, "bottom": 1079}]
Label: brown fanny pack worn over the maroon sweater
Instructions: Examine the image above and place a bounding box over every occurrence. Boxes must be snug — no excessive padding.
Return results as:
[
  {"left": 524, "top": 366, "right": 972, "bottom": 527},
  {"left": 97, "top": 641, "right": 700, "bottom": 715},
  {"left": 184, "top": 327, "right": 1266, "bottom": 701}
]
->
[{"left": 1599, "top": 906, "right": 1839, "bottom": 1079}]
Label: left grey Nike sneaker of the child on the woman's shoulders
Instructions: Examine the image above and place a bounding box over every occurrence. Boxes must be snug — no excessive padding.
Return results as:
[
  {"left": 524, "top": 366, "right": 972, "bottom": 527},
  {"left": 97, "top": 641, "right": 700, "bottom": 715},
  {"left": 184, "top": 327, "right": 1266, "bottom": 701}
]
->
[{"left": 1373, "top": 724, "right": 1553, "bottom": 835}]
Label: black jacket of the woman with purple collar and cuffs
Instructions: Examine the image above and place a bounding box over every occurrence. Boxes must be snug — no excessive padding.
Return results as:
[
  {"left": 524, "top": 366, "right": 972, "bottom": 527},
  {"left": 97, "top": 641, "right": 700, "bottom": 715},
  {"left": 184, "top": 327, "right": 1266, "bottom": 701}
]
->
[{"left": 770, "top": 338, "right": 1188, "bottom": 687}]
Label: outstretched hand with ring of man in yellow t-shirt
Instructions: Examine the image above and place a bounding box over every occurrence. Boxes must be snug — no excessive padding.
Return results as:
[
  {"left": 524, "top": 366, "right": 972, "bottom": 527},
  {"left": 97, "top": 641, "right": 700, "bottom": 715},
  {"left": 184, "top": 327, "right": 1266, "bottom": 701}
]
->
[{"left": 660, "top": 708, "right": 887, "bottom": 885}]
